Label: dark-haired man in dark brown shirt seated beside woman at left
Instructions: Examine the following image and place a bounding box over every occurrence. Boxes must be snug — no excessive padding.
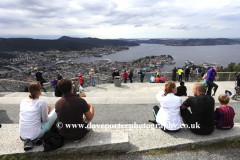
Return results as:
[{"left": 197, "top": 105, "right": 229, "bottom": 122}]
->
[{"left": 55, "top": 79, "right": 94, "bottom": 142}]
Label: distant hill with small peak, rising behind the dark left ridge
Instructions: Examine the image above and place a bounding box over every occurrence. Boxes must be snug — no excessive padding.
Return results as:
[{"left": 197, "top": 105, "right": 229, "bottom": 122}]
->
[{"left": 58, "top": 36, "right": 139, "bottom": 46}]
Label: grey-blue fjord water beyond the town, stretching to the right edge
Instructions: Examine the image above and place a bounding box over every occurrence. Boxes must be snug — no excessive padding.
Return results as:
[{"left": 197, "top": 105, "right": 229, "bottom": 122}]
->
[{"left": 75, "top": 44, "right": 240, "bottom": 71}]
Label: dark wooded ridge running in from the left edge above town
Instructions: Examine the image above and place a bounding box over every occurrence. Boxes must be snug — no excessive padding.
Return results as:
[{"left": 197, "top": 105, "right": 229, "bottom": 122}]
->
[{"left": 0, "top": 38, "right": 97, "bottom": 51}]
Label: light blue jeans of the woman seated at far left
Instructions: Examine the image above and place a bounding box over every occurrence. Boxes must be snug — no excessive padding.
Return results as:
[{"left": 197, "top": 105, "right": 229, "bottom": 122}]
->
[{"left": 36, "top": 109, "right": 57, "bottom": 139}]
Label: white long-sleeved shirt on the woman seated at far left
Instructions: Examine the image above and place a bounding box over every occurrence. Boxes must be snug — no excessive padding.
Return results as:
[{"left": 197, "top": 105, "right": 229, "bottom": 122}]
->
[{"left": 19, "top": 99, "right": 49, "bottom": 140}]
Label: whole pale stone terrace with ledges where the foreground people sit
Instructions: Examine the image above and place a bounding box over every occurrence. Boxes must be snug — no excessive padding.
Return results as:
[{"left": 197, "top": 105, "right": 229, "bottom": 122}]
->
[{"left": 0, "top": 81, "right": 240, "bottom": 156}]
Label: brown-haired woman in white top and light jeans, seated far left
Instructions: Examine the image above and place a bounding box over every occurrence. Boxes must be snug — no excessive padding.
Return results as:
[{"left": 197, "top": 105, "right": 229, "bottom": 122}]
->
[{"left": 19, "top": 81, "right": 57, "bottom": 140}]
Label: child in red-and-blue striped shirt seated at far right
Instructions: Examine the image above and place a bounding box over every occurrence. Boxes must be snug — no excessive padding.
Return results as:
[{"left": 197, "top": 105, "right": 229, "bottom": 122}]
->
[{"left": 214, "top": 94, "right": 235, "bottom": 130}]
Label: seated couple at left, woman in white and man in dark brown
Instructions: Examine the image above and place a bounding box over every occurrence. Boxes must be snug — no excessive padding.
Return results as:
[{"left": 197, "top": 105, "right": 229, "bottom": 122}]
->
[{"left": 19, "top": 79, "right": 94, "bottom": 150}]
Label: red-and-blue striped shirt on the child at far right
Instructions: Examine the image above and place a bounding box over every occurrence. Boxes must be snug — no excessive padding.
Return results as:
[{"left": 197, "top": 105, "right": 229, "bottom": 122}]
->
[{"left": 214, "top": 106, "right": 235, "bottom": 130}]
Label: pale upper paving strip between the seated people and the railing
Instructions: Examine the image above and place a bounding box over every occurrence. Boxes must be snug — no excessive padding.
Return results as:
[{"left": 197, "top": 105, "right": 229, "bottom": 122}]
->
[{"left": 0, "top": 81, "right": 238, "bottom": 104}]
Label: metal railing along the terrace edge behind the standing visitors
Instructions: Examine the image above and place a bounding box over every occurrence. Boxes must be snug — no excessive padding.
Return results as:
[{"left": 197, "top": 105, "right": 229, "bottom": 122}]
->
[{"left": 0, "top": 72, "right": 235, "bottom": 92}]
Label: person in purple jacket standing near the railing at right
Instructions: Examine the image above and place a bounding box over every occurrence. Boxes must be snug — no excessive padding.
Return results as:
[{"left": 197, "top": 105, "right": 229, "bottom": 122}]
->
[{"left": 206, "top": 67, "right": 218, "bottom": 96}]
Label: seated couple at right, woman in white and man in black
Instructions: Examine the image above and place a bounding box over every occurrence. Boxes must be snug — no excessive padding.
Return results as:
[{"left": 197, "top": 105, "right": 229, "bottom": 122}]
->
[{"left": 153, "top": 82, "right": 215, "bottom": 135}]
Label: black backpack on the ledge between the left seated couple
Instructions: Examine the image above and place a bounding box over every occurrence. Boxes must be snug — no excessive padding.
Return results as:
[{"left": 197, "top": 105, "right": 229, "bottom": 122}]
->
[{"left": 43, "top": 125, "right": 63, "bottom": 152}]
